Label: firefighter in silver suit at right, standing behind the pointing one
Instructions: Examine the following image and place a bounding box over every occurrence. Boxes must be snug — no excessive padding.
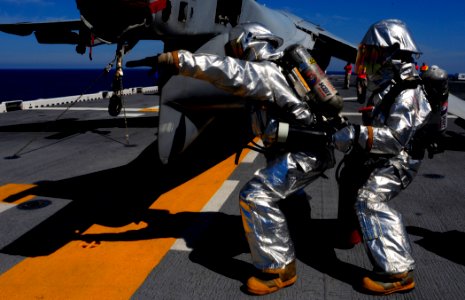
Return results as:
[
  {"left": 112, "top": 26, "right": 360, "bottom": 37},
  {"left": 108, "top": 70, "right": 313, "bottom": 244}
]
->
[{"left": 333, "top": 19, "right": 431, "bottom": 294}]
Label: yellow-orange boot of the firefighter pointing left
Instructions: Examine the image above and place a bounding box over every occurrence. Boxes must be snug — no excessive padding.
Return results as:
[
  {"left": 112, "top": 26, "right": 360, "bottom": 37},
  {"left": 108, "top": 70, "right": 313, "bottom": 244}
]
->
[{"left": 247, "top": 260, "right": 297, "bottom": 295}]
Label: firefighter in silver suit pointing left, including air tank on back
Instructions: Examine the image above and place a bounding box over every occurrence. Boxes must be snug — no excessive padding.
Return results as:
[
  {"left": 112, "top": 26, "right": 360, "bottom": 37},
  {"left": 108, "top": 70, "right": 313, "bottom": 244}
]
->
[{"left": 150, "top": 23, "right": 342, "bottom": 294}]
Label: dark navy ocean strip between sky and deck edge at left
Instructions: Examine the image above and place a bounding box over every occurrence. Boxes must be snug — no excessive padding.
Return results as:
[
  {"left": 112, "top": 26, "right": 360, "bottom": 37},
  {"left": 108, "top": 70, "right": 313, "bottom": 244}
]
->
[{"left": 0, "top": 69, "right": 157, "bottom": 102}]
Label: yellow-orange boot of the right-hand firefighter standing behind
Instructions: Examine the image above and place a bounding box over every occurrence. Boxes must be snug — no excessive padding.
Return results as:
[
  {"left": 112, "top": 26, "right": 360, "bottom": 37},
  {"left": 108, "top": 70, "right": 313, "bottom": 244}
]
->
[{"left": 362, "top": 271, "right": 415, "bottom": 295}]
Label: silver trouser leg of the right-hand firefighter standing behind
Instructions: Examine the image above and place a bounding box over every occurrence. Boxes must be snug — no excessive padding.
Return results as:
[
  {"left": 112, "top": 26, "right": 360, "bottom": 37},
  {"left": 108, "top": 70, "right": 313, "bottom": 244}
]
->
[{"left": 355, "top": 166, "right": 415, "bottom": 274}]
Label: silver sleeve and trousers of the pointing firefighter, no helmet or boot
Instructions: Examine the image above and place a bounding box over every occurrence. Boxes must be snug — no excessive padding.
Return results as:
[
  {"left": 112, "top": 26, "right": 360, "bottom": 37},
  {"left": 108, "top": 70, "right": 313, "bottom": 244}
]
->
[{"left": 178, "top": 47, "right": 334, "bottom": 270}]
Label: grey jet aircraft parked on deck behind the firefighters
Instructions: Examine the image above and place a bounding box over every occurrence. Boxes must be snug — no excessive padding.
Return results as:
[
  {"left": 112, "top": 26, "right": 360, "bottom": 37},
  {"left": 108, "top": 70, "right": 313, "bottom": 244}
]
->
[{"left": 0, "top": 0, "right": 357, "bottom": 163}]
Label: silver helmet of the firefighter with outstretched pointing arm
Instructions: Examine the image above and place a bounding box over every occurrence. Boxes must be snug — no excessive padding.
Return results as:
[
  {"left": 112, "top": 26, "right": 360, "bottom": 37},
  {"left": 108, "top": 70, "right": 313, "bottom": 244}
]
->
[{"left": 226, "top": 23, "right": 283, "bottom": 61}]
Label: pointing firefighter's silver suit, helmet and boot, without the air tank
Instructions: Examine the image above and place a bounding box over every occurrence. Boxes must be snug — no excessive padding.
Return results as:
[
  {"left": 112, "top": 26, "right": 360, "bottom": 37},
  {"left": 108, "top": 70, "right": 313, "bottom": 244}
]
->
[{"left": 150, "top": 23, "right": 342, "bottom": 294}]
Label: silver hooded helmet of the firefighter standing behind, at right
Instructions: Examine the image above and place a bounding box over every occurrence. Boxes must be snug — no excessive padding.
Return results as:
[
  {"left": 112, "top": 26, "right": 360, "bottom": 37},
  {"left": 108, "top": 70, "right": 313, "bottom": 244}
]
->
[{"left": 356, "top": 19, "right": 421, "bottom": 75}]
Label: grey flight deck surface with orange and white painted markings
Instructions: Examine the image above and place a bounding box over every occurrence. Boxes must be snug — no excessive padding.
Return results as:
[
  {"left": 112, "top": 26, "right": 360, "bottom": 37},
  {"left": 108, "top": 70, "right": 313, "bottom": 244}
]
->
[{"left": 0, "top": 77, "right": 465, "bottom": 299}]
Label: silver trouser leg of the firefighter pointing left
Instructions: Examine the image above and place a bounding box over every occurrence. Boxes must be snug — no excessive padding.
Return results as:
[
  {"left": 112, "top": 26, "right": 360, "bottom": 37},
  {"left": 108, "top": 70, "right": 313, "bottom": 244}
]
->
[{"left": 239, "top": 153, "right": 326, "bottom": 270}]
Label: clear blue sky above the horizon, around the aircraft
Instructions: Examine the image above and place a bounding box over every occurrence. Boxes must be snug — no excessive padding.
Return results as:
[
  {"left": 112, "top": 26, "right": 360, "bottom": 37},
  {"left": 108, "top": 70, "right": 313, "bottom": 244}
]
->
[{"left": 0, "top": 0, "right": 465, "bottom": 74}]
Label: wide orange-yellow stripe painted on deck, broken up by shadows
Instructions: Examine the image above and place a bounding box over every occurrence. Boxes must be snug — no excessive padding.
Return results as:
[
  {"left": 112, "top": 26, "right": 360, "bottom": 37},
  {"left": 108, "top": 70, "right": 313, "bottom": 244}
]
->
[{"left": 0, "top": 151, "right": 247, "bottom": 300}]
